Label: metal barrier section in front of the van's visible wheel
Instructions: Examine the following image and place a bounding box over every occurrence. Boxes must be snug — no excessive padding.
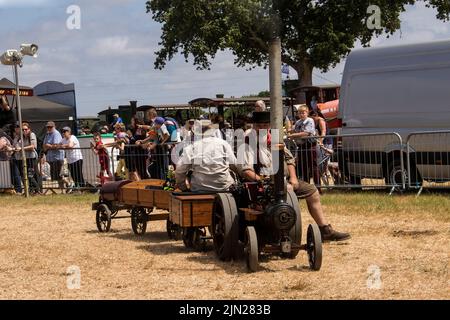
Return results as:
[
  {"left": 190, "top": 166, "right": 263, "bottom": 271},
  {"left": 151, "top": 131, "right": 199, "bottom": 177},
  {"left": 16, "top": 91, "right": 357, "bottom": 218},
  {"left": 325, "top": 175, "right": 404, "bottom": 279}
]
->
[{"left": 286, "top": 133, "right": 406, "bottom": 192}]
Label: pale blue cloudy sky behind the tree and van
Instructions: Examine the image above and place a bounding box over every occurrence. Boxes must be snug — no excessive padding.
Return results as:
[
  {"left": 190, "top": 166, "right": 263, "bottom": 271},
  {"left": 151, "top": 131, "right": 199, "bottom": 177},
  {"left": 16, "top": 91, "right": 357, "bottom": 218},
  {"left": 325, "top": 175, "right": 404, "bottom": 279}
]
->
[{"left": 0, "top": 0, "right": 450, "bottom": 116}]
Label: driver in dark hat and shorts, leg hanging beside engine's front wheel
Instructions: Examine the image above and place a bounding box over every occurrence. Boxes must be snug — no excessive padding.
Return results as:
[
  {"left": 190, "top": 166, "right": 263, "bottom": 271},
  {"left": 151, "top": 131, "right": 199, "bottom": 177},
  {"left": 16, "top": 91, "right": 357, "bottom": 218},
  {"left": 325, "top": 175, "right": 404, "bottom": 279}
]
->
[{"left": 238, "top": 112, "right": 350, "bottom": 241}]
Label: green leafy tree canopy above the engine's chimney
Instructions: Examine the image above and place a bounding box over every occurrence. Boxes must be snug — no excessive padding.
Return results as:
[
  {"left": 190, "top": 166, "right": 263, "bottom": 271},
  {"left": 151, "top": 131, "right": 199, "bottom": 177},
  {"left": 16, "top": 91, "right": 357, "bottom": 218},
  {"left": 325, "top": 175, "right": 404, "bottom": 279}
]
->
[{"left": 147, "top": 0, "right": 450, "bottom": 100}]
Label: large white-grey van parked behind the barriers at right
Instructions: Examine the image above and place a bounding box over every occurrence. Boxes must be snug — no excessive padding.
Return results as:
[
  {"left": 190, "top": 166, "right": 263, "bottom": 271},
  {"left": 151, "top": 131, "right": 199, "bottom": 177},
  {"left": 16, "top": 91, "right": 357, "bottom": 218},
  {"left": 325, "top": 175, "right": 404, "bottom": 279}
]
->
[{"left": 339, "top": 40, "right": 450, "bottom": 184}]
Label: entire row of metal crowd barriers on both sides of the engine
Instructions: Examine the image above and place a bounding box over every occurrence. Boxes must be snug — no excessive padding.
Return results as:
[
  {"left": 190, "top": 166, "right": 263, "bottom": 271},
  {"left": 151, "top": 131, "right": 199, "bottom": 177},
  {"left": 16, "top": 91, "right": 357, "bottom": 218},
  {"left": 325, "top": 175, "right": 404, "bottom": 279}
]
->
[{"left": 0, "top": 131, "right": 450, "bottom": 194}]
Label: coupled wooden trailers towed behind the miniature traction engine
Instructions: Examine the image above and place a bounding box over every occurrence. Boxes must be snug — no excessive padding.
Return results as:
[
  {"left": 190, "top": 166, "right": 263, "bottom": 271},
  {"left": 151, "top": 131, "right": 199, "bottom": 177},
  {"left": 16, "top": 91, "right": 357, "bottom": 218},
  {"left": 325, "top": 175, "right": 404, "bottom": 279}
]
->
[{"left": 92, "top": 179, "right": 215, "bottom": 249}]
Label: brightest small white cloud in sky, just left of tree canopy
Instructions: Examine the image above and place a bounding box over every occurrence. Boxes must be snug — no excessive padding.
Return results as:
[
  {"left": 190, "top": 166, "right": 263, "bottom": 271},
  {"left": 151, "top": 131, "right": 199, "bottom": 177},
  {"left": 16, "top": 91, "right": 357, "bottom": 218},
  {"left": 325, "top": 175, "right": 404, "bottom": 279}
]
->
[{"left": 87, "top": 36, "right": 152, "bottom": 57}]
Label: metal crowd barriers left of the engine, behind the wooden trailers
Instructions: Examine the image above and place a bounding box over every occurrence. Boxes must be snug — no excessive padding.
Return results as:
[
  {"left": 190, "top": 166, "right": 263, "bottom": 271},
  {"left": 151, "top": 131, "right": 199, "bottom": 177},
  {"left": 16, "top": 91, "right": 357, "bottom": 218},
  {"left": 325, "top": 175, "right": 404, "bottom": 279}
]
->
[{"left": 0, "top": 145, "right": 174, "bottom": 194}]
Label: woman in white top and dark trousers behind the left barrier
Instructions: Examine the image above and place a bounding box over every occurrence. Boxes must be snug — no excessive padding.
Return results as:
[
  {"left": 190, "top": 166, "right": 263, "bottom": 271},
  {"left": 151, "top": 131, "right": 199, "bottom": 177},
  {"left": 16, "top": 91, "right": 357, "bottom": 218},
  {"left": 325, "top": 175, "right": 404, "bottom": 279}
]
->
[{"left": 61, "top": 127, "right": 86, "bottom": 188}]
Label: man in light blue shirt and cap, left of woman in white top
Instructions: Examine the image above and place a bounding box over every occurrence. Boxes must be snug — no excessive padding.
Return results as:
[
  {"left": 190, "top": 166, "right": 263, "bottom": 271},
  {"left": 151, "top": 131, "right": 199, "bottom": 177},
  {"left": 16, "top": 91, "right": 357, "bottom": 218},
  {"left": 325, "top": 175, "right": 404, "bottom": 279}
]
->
[{"left": 43, "top": 121, "right": 64, "bottom": 189}]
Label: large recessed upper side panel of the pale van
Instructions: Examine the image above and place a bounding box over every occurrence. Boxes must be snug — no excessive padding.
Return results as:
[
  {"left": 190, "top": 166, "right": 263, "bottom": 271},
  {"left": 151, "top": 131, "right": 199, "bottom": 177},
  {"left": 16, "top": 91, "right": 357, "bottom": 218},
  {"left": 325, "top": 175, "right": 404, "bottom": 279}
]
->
[{"left": 344, "top": 65, "right": 450, "bottom": 130}]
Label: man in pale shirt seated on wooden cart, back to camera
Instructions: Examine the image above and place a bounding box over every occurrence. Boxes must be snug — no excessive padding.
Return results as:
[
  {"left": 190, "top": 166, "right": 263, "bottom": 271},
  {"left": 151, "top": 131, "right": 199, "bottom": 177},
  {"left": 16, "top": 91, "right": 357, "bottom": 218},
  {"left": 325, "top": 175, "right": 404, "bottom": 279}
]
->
[{"left": 175, "top": 120, "right": 237, "bottom": 192}]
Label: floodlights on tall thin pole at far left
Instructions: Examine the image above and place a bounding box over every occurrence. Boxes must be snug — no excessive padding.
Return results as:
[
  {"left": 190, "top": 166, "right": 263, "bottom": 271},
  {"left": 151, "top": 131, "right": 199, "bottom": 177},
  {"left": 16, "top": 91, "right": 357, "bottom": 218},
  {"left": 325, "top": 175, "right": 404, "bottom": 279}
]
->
[{"left": 0, "top": 44, "right": 38, "bottom": 197}]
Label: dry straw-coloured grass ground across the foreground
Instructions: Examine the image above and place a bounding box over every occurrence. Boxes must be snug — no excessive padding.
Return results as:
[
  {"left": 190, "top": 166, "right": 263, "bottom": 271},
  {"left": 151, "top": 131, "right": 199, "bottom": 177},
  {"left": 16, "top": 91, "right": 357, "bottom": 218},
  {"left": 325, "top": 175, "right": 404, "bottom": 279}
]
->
[{"left": 0, "top": 193, "right": 450, "bottom": 299}]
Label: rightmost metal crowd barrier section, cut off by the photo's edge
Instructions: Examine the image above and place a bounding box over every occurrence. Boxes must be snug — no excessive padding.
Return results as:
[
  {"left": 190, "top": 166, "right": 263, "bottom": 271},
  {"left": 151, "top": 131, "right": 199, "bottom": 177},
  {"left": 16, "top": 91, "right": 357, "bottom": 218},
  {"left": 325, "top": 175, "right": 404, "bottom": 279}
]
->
[{"left": 406, "top": 131, "right": 450, "bottom": 194}]
